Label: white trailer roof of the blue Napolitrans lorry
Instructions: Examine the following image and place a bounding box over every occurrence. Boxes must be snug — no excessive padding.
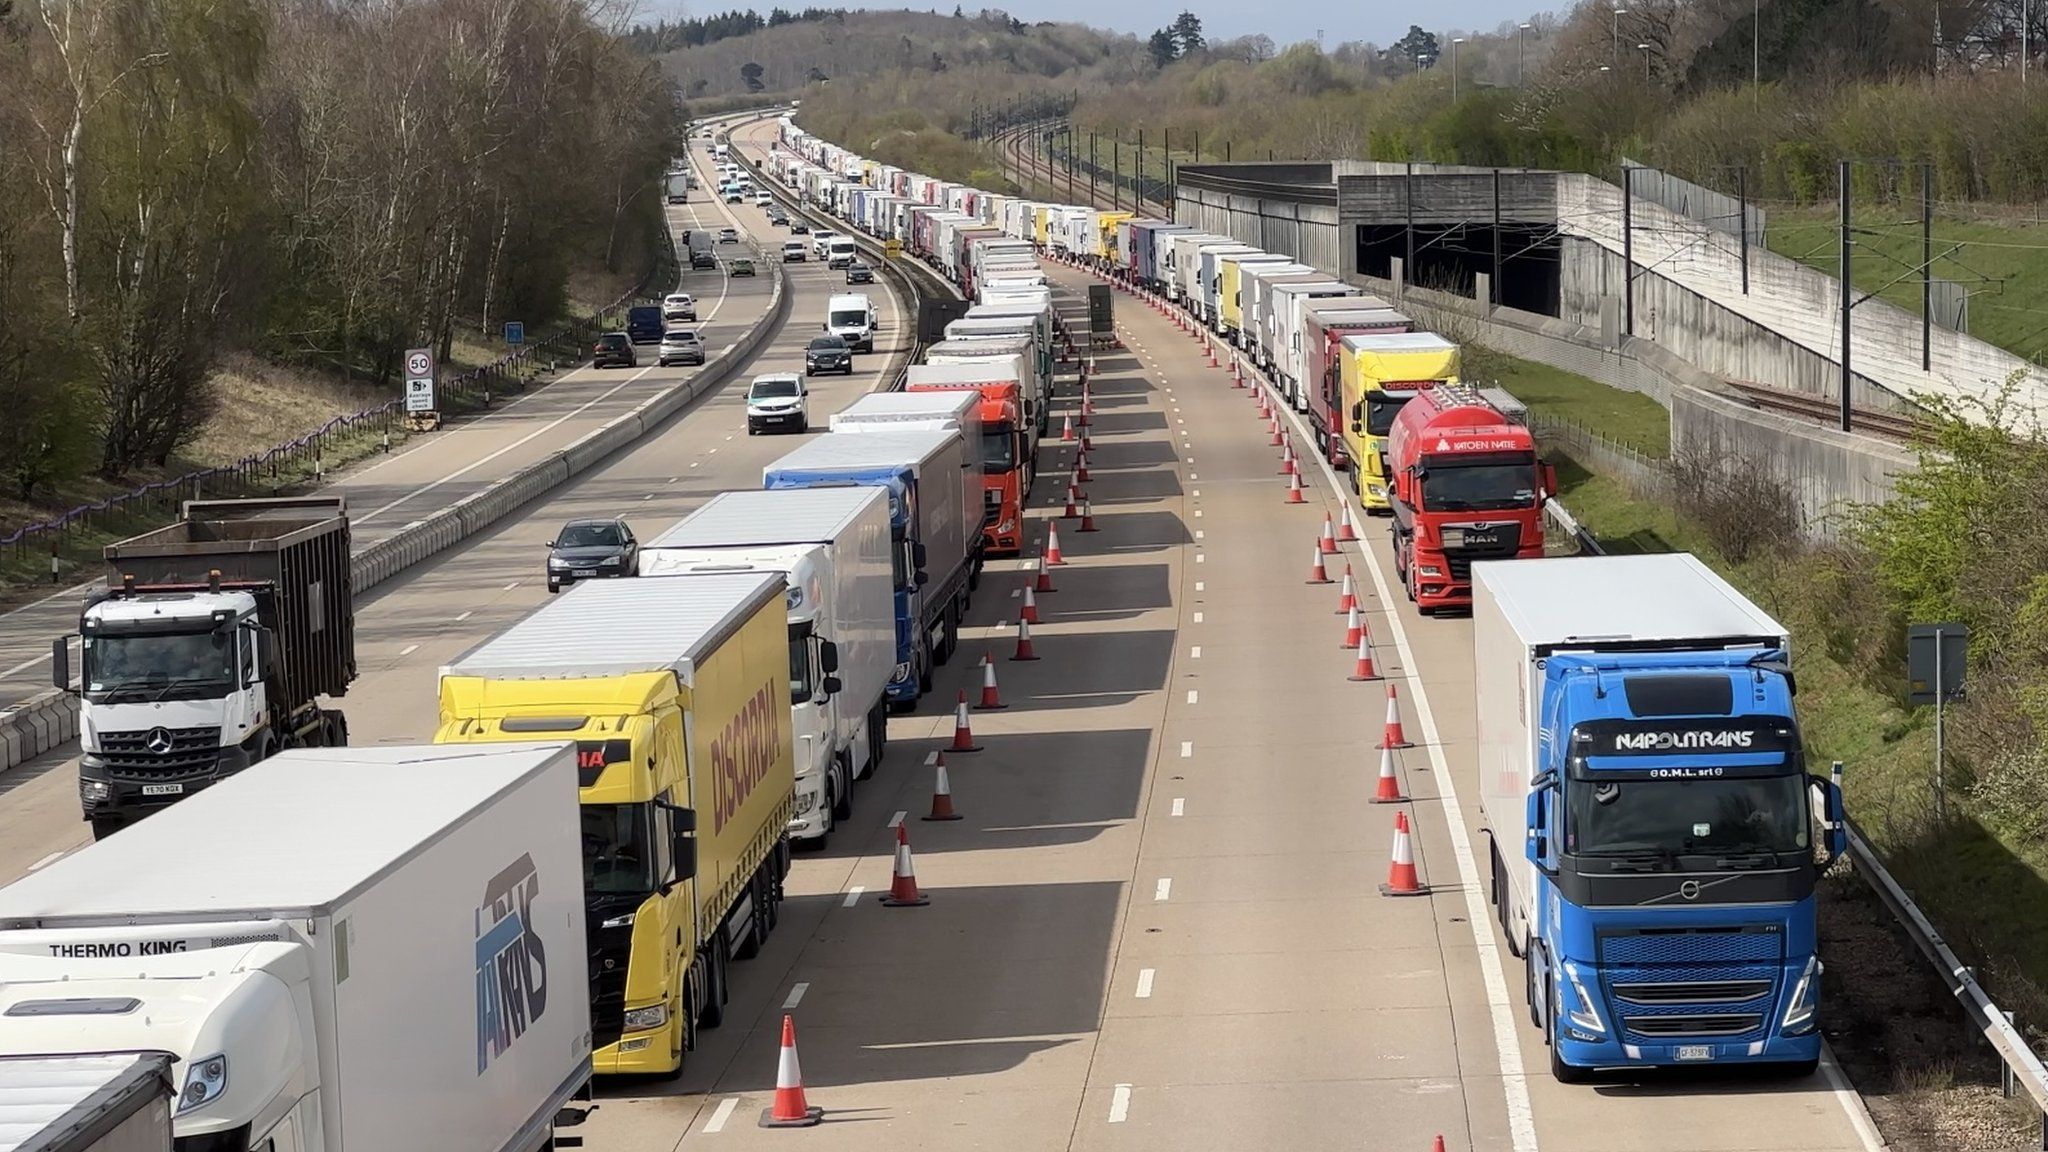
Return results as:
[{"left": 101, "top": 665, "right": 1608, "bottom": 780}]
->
[{"left": 1473, "top": 551, "right": 1790, "bottom": 652}]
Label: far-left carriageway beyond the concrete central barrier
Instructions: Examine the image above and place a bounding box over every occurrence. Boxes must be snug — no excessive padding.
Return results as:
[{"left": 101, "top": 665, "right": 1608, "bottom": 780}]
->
[{"left": 0, "top": 114, "right": 780, "bottom": 711}]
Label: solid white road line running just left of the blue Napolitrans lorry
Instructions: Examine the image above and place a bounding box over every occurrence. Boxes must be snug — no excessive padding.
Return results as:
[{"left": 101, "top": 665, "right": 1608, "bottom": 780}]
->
[{"left": 1286, "top": 362, "right": 1538, "bottom": 1152}]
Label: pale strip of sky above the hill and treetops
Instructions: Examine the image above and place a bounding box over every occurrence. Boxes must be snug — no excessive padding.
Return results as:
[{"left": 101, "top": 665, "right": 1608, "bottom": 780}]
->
[{"left": 641, "top": 0, "right": 1563, "bottom": 47}]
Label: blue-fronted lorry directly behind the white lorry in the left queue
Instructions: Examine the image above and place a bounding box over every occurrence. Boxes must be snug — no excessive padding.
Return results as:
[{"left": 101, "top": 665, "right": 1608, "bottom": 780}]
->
[{"left": 762, "top": 428, "right": 983, "bottom": 711}]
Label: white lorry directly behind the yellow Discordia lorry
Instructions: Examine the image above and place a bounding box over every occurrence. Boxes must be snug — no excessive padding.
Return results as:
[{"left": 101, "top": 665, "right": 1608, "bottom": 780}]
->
[{"left": 641, "top": 483, "right": 895, "bottom": 847}]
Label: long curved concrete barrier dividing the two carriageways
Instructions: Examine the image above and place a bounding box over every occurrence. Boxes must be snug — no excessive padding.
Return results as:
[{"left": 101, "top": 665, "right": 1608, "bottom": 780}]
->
[{"left": 0, "top": 262, "right": 788, "bottom": 771}]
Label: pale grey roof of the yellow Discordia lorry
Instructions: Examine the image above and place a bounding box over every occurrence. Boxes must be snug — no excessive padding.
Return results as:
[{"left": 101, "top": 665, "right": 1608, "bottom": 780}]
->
[{"left": 440, "top": 572, "right": 782, "bottom": 685}]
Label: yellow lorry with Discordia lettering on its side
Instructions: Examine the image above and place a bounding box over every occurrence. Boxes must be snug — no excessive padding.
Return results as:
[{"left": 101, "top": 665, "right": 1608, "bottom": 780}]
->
[{"left": 436, "top": 572, "right": 797, "bottom": 1076}]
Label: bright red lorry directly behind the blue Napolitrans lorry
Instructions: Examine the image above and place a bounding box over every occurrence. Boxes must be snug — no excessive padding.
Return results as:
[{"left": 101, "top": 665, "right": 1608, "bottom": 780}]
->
[{"left": 1386, "top": 383, "right": 1556, "bottom": 615}]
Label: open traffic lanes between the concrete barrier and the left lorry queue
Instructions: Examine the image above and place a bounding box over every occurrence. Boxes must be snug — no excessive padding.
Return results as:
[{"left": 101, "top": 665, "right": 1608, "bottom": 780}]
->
[{"left": 0, "top": 116, "right": 911, "bottom": 881}]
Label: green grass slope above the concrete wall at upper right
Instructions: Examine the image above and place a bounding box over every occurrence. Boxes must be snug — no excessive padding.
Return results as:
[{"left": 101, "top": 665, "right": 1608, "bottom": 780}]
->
[{"left": 1765, "top": 205, "right": 2048, "bottom": 363}]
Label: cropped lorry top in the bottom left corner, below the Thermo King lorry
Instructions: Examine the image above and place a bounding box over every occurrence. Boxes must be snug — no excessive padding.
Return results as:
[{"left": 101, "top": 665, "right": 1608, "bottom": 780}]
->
[{"left": 0, "top": 1052, "right": 176, "bottom": 1152}]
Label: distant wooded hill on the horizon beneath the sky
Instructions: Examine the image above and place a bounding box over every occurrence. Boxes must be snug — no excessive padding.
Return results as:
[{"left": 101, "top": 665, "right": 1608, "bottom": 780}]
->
[{"left": 633, "top": 8, "right": 1145, "bottom": 98}]
